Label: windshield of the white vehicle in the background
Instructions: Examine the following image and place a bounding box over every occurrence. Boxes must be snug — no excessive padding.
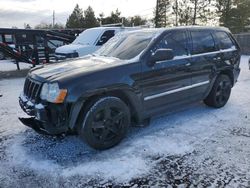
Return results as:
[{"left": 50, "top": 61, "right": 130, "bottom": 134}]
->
[{"left": 72, "top": 29, "right": 101, "bottom": 45}]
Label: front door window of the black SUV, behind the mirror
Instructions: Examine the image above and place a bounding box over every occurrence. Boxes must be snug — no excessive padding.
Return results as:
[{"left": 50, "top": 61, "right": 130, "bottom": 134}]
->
[{"left": 152, "top": 31, "right": 188, "bottom": 57}]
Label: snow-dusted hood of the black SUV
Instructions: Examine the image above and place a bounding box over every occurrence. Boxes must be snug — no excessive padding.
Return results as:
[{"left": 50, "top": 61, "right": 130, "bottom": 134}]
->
[{"left": 30, "top": 56, "right": 124, "bottom": 81}]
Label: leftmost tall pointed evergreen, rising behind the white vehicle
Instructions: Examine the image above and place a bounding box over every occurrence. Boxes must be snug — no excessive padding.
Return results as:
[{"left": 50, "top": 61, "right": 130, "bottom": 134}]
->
[{"left": 66, "top": 4, "right": 84, "bottom": 28}]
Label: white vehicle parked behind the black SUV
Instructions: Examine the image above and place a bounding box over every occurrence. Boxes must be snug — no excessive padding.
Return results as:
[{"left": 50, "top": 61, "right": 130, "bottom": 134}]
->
[{"left": 55, "top": 27, "right": 135, "bottom": 60}]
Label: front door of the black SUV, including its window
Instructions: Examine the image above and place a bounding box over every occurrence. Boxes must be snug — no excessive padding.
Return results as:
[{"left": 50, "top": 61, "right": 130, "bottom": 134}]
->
[{"left": 141, "top": 30, "right": 191, "bottom": 112}]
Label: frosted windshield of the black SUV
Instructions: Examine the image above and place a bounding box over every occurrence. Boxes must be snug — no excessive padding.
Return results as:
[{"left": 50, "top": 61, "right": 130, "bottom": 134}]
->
[{"left": 96, "top": 31, "right": 158, "bottom": 60}]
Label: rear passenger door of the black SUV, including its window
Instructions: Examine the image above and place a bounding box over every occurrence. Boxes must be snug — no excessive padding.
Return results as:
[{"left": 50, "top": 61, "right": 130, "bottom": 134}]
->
[{"left": 190, "top": 29, "right": 221, "bottom": 98}]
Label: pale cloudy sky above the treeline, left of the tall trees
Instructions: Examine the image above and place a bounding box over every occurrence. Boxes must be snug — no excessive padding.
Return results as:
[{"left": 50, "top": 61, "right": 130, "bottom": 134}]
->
[{"left": 0, "top": 0, "right": 156, "bottom": 28}]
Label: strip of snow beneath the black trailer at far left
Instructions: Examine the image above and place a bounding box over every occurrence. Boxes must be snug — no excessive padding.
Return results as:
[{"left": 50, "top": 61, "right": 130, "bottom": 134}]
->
[{"left": 0, "top": 60, "right": 32, "bottom": 71}]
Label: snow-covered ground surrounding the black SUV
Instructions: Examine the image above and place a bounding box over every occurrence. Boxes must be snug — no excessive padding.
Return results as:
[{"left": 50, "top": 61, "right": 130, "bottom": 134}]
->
[{"left": 0, "top": 56, "right": 250, "bottom": 187}]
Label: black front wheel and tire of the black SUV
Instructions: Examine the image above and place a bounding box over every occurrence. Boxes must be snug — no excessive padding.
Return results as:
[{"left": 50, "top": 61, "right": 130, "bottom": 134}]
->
[{"left": 78, "top": 97, "right": 130, "bottom": 150}]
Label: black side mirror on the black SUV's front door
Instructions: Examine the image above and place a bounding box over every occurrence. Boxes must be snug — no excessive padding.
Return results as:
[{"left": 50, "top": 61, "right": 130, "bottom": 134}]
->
[{"left": 150, "top": 49, "right": 174, "bottom": 65}]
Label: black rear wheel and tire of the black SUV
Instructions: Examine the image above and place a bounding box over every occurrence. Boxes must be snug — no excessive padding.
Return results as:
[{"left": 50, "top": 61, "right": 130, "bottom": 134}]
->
[{"left": 204, "top": 75, "right": 232, "bottom": 108}]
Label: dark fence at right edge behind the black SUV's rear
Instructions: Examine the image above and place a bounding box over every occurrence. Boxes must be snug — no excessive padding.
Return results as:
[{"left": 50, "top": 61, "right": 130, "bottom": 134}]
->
[{"left": 234, "top": 33, "right": 250, "bottom": 55}]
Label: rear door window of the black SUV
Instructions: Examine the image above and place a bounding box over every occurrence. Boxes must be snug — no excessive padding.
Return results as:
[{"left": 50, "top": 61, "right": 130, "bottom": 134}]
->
[{"left": 191, "top": 31, "right": 216, "bottom": 55}]
